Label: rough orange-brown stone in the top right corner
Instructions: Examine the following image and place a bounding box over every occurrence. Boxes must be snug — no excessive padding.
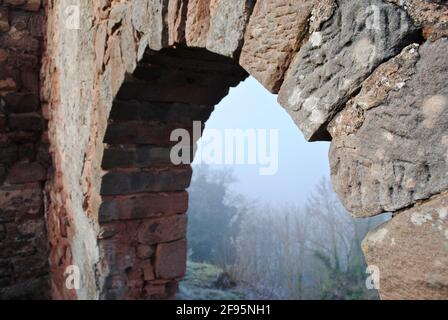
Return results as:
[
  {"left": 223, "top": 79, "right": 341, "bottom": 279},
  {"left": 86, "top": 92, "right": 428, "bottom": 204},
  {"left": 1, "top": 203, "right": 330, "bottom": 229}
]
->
[{"left": 386, "top": 0, "right": 448, "bottom": 40}]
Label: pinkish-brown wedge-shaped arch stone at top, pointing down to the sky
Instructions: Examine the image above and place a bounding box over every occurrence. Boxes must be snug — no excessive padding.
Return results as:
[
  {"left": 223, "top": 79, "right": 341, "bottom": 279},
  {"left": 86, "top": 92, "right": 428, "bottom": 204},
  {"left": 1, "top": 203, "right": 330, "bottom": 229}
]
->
[{"left": 240, "top": 0, "right": 314, "bottom": 93}]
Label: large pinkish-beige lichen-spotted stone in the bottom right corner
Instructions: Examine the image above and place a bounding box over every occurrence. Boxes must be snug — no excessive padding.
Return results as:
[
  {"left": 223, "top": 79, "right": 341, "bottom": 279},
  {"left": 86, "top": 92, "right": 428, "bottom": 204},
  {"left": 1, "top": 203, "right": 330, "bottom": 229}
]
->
[{"left": 362, "top": 194, "right": 448, "bottom": 300}]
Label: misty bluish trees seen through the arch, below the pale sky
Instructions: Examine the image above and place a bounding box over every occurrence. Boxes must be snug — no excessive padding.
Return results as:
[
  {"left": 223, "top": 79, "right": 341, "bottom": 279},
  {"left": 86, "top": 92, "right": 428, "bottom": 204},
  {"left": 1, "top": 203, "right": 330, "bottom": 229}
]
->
[{"left": 188, "top": 166, "right": 385, "bottom": 299}]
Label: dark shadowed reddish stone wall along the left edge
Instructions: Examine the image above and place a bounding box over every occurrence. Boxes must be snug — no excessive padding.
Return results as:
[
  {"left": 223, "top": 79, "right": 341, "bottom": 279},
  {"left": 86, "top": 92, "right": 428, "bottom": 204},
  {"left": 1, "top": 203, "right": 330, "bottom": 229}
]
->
[{"left": 0, "top": 0, "right": 51, "bottom": 298}]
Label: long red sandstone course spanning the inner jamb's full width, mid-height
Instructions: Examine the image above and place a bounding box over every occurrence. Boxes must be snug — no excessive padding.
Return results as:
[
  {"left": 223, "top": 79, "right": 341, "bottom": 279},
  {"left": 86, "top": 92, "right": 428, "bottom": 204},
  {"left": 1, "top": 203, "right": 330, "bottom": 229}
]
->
[{"left": 99, "top": 192, "right": 188, "bottom": 223}]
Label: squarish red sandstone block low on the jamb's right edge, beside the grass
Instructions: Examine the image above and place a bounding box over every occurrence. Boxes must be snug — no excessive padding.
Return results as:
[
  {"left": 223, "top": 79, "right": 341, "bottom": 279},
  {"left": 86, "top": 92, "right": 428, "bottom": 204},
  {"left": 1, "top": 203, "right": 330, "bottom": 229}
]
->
[{"left": 155, "top": 240, "right": 187, "bottom": 279}]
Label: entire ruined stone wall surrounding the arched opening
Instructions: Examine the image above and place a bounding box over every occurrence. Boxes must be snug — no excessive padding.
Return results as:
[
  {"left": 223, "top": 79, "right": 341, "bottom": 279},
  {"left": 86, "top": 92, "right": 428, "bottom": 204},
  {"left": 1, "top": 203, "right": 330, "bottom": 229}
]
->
[{"left": 0, "top": 0, "right": 448, "bottom": 299}]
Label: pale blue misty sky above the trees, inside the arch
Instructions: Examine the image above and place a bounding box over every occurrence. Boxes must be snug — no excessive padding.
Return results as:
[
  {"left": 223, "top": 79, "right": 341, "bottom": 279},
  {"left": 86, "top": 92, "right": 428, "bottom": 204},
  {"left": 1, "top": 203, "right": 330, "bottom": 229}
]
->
[{"left": 195, "top": 77, "right": 329, "bottom": 204}]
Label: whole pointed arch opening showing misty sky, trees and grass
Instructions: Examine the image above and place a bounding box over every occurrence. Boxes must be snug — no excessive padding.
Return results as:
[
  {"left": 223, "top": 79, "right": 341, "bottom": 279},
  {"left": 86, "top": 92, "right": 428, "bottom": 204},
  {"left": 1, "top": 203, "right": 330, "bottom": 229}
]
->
[{"left": 177, "top": 77, "right": 383, "bottom": 300}]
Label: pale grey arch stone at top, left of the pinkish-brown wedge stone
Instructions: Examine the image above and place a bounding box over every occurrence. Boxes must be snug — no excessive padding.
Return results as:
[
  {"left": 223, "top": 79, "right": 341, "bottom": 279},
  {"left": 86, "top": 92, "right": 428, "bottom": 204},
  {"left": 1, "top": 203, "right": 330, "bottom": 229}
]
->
[{"left": 206, "top": 0, "right": 255, "bottom": 58}]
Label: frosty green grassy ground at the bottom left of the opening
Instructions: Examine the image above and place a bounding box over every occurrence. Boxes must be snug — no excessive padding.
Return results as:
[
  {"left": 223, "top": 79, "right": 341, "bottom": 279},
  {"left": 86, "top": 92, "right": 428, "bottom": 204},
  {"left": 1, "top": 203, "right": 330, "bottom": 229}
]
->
[{"left": 177, "top": 261, "right": 245, "bottom": 300}]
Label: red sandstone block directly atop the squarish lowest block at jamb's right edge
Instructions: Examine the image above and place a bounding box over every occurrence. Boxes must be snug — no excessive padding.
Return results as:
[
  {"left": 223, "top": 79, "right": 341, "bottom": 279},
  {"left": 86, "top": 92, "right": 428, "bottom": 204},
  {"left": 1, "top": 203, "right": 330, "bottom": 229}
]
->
[{"left": 137, "top": 214, "right": 187, "bottom": 245}]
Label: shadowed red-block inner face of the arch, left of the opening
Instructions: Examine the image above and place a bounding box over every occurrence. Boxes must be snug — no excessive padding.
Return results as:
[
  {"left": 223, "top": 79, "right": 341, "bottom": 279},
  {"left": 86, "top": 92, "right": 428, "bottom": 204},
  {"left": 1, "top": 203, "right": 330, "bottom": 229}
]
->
[{"left": 99, "top": 48, "right": 247, "bottom": 299}]
